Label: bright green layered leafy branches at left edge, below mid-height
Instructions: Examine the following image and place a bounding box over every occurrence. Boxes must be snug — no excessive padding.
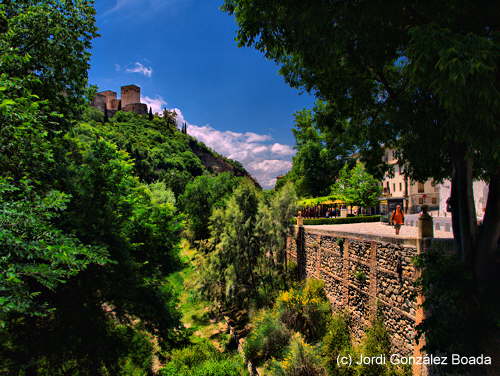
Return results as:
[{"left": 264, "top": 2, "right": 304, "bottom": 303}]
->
[{"left": 0, "top": 177, "right": 109, "bottom": 318}]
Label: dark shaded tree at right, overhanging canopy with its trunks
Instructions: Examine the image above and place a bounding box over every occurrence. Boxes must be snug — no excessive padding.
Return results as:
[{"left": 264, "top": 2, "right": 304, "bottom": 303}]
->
[{"left": 223, "top": 0, "right": 500, "bottom": 286}]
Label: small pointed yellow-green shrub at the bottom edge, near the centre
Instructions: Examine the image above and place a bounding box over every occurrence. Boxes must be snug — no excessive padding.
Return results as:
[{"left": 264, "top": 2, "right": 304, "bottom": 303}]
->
[{"left": 268, "top": 333, "right": 327, "bottom": 376}]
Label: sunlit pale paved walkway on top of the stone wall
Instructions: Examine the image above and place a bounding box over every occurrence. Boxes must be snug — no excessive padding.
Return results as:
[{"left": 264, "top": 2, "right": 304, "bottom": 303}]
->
[{"left": 304, "top": 222, "right": 453, "bottom": 239}]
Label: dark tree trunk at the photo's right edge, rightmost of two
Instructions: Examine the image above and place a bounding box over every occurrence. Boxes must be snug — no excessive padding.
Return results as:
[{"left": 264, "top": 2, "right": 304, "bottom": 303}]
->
[{"left": 474, "top": 169, "right": 500, "bottom": 289}]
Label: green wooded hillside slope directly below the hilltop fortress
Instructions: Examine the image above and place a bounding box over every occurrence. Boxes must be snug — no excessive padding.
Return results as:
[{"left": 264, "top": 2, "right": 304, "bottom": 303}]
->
[{"left": 84, "top": 108, "right": 257, "bottom": 195}]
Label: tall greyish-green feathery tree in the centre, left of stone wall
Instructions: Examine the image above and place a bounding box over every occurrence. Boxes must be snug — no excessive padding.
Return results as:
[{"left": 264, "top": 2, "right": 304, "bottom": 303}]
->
[{"left": 197, "top": 181, "right": 295, "bottom": 314}]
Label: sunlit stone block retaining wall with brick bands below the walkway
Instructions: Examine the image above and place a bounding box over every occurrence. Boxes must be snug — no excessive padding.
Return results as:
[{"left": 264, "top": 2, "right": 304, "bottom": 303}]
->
[{"left": 287, "top": 227, "right": 417, "bottom": 356}]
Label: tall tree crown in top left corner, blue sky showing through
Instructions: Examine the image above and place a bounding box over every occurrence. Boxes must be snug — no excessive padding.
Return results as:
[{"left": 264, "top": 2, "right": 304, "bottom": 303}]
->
[{"left": 0, "top": 0, "right": 97, "bottom": 118}]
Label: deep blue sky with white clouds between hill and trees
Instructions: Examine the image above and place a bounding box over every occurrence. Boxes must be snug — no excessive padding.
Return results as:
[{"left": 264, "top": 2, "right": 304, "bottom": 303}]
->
[{"left": 89, "top": 0, "right": 314, "bottom": 187}]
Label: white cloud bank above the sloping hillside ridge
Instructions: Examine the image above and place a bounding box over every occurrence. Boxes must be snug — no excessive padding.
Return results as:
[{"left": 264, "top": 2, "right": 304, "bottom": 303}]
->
[{"left": 173, "top": 108, "right": 295, "bottom": 188}]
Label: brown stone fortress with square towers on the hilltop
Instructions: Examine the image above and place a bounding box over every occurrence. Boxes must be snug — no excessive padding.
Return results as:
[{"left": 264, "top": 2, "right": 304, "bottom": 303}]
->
[{"left": 92, "top": 85, "right": 148, "bottom": 116}]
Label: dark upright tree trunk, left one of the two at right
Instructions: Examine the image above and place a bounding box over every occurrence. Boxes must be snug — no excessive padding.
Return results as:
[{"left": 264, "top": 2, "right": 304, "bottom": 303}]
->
[{"left": 451, "top": 148, "right": 477, "bottom": 268}]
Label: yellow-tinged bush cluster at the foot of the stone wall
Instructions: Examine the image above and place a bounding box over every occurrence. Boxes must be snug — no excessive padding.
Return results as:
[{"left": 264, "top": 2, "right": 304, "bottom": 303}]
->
[{"left": 243, "top": 279, "right": 331, "bottom": 376}]
